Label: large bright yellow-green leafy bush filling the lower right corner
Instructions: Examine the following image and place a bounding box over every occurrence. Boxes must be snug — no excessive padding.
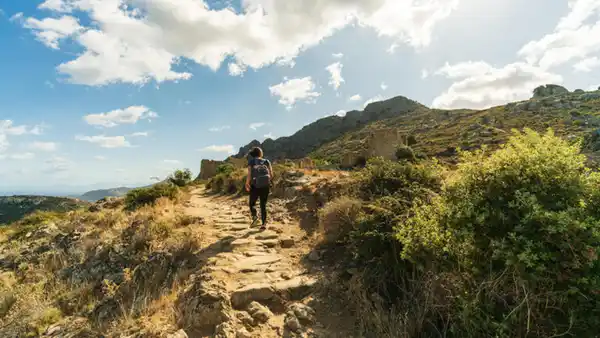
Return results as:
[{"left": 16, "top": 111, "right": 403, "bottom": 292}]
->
[{"left": 397, "top": 130, "right": 600, "bottom": 337}]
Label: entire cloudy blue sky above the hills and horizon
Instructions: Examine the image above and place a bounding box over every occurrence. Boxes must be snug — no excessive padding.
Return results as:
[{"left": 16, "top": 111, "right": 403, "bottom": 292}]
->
[{"left": 0, "top": 0, "right": 600, "bottom": 193}]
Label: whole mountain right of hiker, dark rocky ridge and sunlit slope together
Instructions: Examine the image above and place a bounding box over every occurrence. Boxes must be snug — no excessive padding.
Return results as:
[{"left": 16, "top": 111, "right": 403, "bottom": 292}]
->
[{"left": 234, "top": 85, "right": 600, "bottom": 164}]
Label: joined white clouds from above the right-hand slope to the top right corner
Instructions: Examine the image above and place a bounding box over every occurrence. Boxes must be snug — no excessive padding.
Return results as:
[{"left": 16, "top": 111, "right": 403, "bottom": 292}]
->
[{"left": 432, "top": 0, "right": 600, "bottom": 109}]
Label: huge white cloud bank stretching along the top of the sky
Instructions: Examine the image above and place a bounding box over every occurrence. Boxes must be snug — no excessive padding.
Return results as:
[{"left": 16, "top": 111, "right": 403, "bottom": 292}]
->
[{"left": 21, "top": 0, "right": 459, "bottom": 85}]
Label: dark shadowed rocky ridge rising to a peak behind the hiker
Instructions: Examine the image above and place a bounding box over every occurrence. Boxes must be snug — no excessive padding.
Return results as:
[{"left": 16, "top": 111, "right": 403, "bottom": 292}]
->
[{"left": 234, "top": 96, "right": 428, "bottom": 160}]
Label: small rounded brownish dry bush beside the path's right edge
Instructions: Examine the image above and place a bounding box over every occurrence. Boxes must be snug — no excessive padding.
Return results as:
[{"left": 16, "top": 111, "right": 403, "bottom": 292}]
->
[{"left": 319, "top": 196, "right": 362, "bottom": 242}]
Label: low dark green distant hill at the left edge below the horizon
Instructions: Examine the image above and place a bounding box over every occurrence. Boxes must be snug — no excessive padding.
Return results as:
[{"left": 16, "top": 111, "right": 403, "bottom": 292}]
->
[{"left": 0, "top": 196, "right": 89, "bottom": 224}]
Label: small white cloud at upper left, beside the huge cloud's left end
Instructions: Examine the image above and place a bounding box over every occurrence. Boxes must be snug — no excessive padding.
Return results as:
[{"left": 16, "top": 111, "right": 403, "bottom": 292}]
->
[{"left": 23, "top": 15, "right": 83, "bottom": 49}]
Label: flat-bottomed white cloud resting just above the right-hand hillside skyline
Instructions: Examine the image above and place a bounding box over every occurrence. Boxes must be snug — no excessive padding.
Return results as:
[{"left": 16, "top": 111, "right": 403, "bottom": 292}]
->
[{"left": 432, "top": 61, "right": 562, "bottom": 109}]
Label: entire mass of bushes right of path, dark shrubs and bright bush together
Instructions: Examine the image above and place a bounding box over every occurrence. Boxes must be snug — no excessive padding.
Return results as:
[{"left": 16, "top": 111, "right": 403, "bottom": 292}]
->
[{"left": 320, "top": 130, "right": 600, "bottom": 337}]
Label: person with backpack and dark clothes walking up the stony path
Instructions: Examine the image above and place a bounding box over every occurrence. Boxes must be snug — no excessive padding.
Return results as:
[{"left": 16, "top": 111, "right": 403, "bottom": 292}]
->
[{"left": 246, "top": 147, "right": 273, "bottom": 230}]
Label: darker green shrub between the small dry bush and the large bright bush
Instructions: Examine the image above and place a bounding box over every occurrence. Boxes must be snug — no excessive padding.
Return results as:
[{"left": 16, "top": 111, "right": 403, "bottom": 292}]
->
[{"left": 346, "top": 158, "right": 442, "bottom": 299}]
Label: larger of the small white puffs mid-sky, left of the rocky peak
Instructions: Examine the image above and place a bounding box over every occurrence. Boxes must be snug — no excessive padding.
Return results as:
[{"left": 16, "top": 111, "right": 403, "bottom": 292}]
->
[{"left": 269, "top": 76, "right": 321, "bottom": 110}]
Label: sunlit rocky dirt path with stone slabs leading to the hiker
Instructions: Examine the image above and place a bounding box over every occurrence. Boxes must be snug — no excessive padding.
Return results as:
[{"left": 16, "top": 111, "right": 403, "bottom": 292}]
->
[{"left": 179, "top": 189, "right": 328, "bottom": 338}]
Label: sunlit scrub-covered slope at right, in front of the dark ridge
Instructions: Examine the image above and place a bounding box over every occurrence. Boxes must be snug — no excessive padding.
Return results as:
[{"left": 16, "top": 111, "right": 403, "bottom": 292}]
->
[{"left": 311, "top": 87, "right": 600, "bottom": 163}]
